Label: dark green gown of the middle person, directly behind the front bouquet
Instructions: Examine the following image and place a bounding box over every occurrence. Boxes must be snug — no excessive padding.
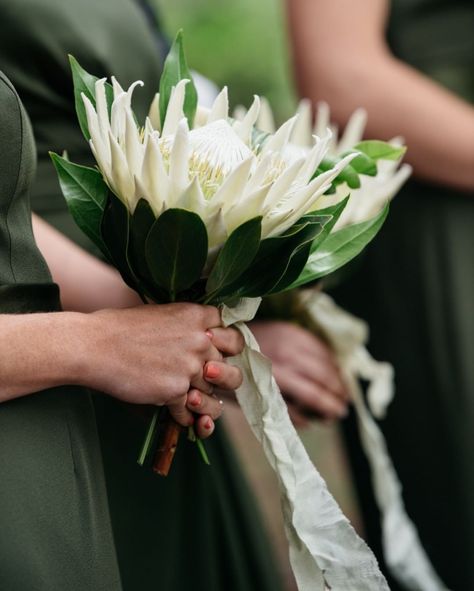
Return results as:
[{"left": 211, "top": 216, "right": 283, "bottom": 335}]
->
[{"left": 0, "top": 0, "right": 281, "bottom": 591}]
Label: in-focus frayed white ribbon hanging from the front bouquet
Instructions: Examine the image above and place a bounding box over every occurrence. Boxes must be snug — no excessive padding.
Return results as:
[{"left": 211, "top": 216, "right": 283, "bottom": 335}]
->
[{"left": 222, "top": 299, "right": 389, "bottom": 591}]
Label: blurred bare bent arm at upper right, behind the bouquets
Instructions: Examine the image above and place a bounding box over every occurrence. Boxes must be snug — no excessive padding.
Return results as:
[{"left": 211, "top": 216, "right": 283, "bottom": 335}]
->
[{"left": 287, "top": 0, "right": 474, "bottom": 191}]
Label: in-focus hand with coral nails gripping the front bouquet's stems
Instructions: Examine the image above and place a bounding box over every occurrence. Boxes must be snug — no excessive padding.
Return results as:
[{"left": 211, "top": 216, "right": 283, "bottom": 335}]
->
[{"left": 76, "top": 304, "right": 243, "bottom": 436}]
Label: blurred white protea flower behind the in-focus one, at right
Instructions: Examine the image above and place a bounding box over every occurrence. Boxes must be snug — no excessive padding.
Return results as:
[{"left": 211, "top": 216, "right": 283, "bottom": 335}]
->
[{"left": 234, "top": 98, "right": 412, "bottom": 229}]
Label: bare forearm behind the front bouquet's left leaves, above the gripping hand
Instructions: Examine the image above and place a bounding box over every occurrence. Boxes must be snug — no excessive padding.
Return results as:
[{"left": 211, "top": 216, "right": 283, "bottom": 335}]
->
[{"left": 33, "top": 215, "right": 139, "bottom": 312}]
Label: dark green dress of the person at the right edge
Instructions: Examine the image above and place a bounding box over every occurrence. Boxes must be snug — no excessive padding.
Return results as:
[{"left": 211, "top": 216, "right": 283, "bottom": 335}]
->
[{"left": 334, "top": 0, "right": 474, "bottom": 591}]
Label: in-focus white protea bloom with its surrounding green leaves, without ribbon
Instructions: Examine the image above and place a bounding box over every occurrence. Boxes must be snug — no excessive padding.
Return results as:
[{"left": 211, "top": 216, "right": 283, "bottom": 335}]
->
[{"left": 51, "top": 33, "right": 404, "bottom": 476}]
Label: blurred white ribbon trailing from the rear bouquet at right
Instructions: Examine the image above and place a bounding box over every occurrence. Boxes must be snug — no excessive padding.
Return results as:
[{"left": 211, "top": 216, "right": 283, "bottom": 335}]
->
[{"left": 297, "top": 290, "right": 448, "bottom": 591}]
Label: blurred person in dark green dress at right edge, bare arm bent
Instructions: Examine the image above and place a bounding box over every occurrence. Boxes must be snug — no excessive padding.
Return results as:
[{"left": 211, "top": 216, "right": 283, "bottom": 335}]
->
[{"left": 288, "top": 0, "right": 474, "bottom": 591}]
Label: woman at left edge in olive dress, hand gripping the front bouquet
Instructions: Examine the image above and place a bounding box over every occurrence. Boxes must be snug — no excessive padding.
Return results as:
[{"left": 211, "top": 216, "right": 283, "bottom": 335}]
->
[{"left": 0, "top": 72, "right": 243, "bottom": 591}]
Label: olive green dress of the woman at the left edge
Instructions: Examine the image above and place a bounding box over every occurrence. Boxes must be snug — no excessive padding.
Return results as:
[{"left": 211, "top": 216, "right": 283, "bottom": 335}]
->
[{"left": 0, "top": 72, "right": 122, "bottom": 591}]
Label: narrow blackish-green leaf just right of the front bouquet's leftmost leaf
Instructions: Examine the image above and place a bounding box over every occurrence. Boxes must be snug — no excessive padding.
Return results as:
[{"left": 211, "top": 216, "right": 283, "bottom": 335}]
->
[{"left": 101, "top": 192, "right": 138, "bottom": 295}]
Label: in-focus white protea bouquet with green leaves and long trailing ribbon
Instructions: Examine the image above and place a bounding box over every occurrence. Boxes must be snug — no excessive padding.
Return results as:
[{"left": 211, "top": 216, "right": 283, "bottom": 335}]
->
[{"left": 51, "top": 33, "right": 410, "bottom": 591}]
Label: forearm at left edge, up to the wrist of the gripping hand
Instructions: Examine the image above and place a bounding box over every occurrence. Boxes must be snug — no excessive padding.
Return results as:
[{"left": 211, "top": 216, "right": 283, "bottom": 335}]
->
[{"left": 0, "top": 312, "right": 84, "bottom": 402}]
